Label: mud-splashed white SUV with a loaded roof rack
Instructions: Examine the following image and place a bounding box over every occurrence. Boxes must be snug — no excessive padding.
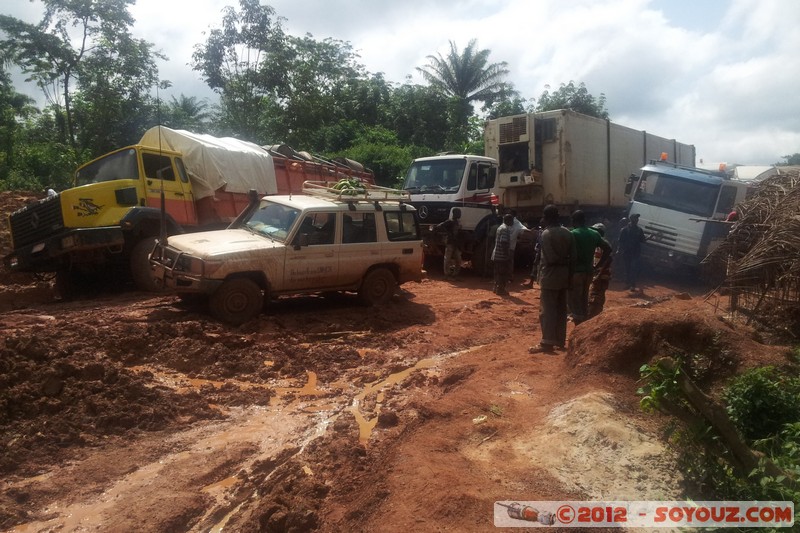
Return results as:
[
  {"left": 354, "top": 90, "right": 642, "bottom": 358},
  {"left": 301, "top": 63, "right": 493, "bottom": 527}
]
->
[{"left": 150, "top": 183, "right": 422, "bottom": 324}]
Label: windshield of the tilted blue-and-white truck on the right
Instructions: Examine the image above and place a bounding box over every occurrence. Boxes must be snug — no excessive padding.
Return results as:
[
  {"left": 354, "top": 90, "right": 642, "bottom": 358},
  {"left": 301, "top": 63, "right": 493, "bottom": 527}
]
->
[{"left": 634, "top": 172, "right": 719, "bottom": 217}]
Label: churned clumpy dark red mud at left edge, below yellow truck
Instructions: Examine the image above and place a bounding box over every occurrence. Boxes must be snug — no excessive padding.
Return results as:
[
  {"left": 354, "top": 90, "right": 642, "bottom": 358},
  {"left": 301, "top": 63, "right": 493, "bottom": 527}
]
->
[{"left": 0, "top": 326, "right": 225, "bottom": 474}]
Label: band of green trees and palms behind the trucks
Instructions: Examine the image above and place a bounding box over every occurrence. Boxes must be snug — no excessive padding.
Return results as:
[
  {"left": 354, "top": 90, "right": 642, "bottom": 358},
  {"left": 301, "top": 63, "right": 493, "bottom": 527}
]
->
[{"left": 0, "top": 0, "right": 604, "bottom": 190}]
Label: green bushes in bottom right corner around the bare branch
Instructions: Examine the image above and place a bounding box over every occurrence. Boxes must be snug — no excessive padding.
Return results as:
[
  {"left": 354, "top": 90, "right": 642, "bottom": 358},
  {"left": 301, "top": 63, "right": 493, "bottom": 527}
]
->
[{"left": 639, "top": 361, "right": 800, "bottom": 505}]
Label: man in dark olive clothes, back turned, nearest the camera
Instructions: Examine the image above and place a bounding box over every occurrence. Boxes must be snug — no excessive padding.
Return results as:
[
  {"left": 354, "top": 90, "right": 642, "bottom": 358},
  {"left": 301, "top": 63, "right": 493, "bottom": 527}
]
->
[{"left": 528, "top": 205, "right": 576, "bottom": 354}]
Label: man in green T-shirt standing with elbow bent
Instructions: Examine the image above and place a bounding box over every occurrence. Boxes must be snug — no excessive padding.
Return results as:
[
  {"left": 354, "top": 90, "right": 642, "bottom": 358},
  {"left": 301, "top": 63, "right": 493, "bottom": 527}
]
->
[{"left": 569, "top": 209, "right": 611, "bottom": 325}]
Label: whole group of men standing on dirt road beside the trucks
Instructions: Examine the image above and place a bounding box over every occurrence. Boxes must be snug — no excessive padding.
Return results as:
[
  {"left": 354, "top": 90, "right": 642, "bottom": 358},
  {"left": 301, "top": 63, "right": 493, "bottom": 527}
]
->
[{"left": 437, "top": 205, "right": 646, "bottom": 353}]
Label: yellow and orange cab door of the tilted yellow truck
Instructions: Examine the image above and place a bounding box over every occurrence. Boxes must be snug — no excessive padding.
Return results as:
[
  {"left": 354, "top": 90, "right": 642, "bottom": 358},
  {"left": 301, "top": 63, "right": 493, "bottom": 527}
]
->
[{"left": 142, "top": 152, "right": 197, "bottom": 225}]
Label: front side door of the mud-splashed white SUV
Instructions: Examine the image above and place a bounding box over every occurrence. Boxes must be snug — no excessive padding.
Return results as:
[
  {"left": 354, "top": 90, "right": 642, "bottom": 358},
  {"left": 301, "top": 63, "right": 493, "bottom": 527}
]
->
[{"left": 278, "top": 212, "right": 339, "bottom": 291}]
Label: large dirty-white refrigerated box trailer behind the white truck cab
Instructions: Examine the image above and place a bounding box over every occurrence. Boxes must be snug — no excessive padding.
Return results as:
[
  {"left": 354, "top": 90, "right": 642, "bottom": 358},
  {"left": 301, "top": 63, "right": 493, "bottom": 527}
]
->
[{"left": 484, "top": 109, "right": 695, "bottom": 217}]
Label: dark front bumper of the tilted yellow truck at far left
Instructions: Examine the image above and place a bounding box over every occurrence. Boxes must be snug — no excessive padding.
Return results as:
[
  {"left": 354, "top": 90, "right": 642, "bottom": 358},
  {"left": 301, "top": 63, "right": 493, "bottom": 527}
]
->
[{"left": 3, "top": 227, "right": 125, "bottom": 272}]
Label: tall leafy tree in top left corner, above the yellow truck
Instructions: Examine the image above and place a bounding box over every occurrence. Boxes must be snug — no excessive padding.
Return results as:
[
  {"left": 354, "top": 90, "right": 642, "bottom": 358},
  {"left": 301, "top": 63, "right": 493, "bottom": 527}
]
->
[{"left": 0, "top": 0, "right": 155, "bottom": 154}]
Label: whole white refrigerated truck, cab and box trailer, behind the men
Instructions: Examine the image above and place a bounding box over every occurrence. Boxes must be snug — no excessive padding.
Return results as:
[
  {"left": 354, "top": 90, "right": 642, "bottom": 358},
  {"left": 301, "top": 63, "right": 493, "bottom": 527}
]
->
[{"left": 404, "top": 110, "right": 695, "bottom": 270}]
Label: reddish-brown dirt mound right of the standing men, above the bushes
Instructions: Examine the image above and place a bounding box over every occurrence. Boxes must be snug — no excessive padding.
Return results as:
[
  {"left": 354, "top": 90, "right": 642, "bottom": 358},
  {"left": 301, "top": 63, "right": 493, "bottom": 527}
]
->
[{"left": 565, "top": 298, "right": 787, "bottom": 383}]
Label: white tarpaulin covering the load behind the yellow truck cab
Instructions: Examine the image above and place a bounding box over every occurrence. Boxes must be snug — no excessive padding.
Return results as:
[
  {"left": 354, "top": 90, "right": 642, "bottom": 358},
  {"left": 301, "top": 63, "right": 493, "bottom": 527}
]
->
[{"left": 139, "top": 126, "right": 278, "bottom": 200}]
